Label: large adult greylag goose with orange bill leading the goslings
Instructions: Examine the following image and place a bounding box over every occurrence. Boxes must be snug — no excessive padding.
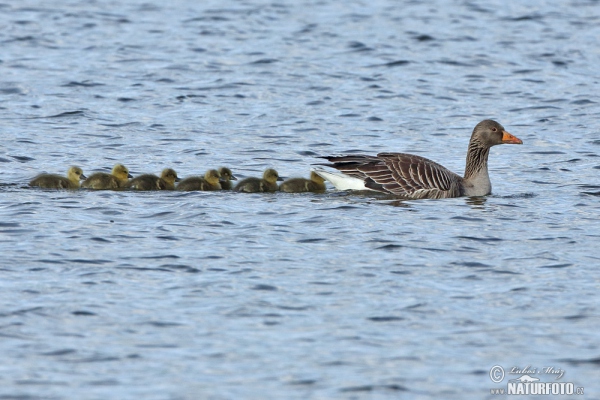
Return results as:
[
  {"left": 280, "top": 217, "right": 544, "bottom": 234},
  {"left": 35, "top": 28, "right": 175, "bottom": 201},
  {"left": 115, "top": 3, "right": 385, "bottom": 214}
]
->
[{"left": 315, "top": 119, "right": 523, "bottom": 199}]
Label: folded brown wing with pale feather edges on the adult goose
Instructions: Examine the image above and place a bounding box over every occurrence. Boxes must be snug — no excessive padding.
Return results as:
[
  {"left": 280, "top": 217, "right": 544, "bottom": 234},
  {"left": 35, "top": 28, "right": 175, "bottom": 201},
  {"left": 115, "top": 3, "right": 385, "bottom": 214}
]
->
[{"left": 325, "top": 153, "right": 463, "bottom": 199}]
